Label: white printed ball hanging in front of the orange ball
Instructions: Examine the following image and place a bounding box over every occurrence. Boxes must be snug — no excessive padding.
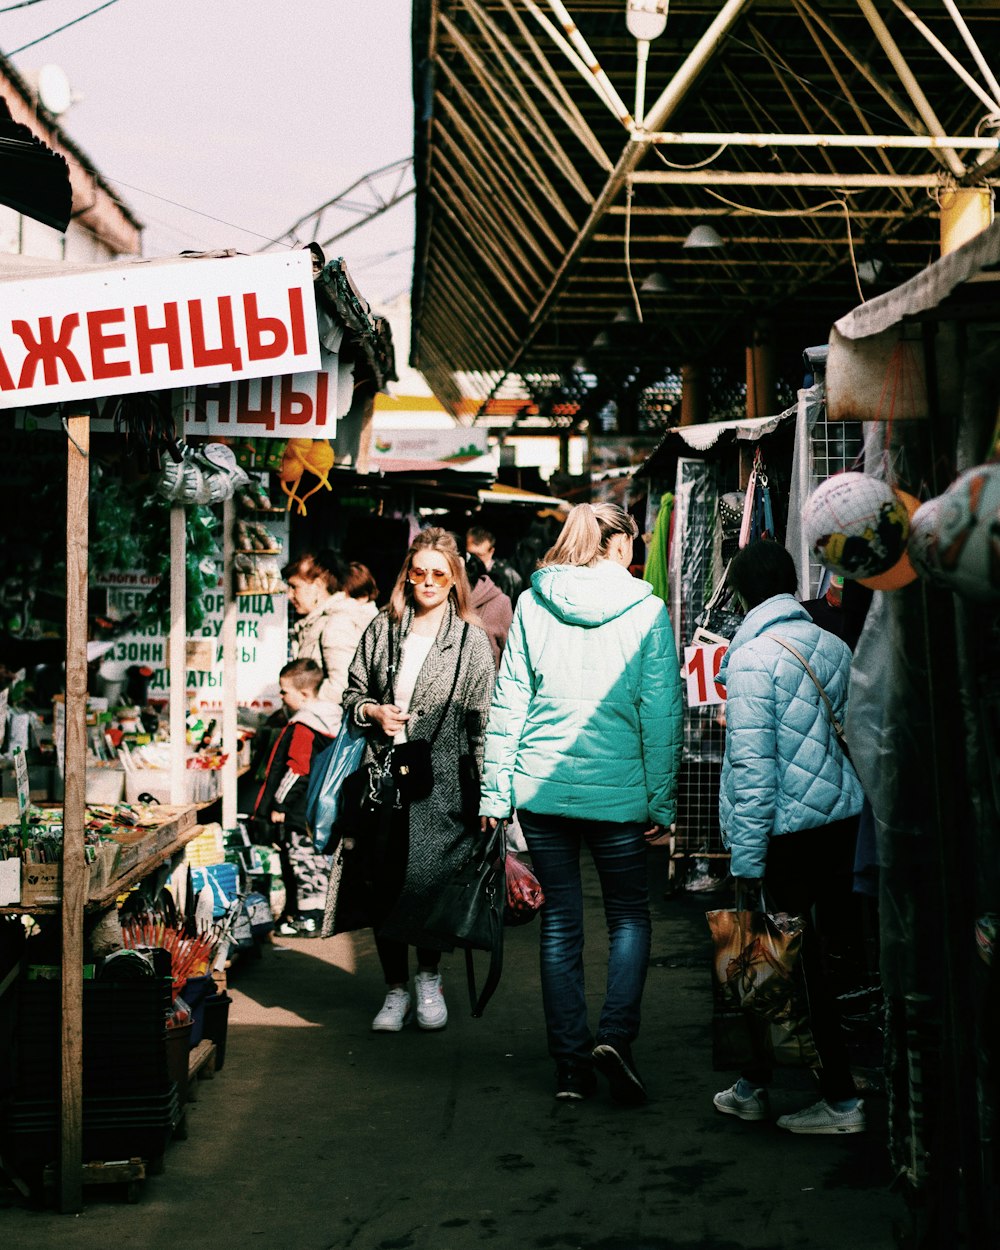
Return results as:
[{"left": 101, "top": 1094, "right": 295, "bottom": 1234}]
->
[{"left": 803, "top": 473, "right": 910, "bottom": 578}]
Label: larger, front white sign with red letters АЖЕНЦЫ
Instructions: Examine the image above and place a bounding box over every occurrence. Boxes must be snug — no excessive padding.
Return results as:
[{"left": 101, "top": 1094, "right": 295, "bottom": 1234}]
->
[{"left": 0, "top": 251, "right": 320, "bottom": 408}]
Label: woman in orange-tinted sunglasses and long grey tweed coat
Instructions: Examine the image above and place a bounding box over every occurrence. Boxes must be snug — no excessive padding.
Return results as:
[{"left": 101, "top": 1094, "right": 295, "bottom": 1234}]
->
[{"left": 323, "top": 528, "right": 495, "bottom": 1033}]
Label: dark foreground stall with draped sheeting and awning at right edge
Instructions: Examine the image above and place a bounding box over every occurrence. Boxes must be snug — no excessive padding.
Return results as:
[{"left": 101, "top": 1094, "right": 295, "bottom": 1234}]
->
[{"left": 828, "top": 223, "right": 1000, "bottom": 1245}]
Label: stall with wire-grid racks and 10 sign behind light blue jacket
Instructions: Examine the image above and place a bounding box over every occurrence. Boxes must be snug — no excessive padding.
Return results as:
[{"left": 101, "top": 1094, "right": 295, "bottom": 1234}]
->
[{"left": 635, "top": 375, "right": 861, "bottom": 889}]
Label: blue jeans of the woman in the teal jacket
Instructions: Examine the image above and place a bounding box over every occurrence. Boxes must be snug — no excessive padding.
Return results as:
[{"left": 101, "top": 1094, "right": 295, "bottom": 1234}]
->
[{"left": 518, "top": 811, "right": 651, "bottom": 1064}]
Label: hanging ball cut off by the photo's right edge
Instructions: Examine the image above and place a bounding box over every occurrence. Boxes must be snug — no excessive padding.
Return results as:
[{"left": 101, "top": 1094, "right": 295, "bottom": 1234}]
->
[{"left": 910, "top": 461, "right": 1000, "bottom": 603}]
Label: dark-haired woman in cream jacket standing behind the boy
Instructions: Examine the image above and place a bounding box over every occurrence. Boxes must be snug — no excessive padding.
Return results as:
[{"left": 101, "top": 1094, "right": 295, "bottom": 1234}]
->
[{"left": 283, "top": 551, "right": 375, "bottom": 731}]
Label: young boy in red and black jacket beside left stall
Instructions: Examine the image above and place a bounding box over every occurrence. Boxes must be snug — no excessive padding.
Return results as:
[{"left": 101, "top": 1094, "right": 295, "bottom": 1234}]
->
[{"left": 251, "top": 660, "right": 340, "bottom": 936}]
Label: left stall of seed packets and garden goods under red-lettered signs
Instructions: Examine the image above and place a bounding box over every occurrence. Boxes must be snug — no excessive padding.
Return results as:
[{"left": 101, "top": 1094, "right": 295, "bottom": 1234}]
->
[{"left": 0, "top": 250, "right": 391, "bottom": 1211}]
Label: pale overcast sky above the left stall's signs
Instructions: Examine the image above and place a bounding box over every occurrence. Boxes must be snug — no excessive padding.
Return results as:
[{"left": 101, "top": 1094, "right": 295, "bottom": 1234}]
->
[{"left": 0, "top": 0, "right": 413, "bottom": 304}]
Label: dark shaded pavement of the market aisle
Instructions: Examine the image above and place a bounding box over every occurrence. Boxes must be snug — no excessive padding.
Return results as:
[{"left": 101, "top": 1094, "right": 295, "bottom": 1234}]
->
[{"left": 0, "top": 850, "right": 904, "bottom": 1250}]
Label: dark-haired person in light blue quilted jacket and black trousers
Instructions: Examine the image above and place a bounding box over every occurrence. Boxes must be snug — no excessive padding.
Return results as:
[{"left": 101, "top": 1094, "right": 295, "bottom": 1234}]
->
[{"left": 714, "top": 541, "right": 865, "bottom": 1134}]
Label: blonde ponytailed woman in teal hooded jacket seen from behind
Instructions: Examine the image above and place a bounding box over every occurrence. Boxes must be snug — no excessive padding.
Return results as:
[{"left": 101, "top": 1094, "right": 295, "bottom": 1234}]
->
[{"left": 480, "top": 504, "right": 683, "bottom": 1105}]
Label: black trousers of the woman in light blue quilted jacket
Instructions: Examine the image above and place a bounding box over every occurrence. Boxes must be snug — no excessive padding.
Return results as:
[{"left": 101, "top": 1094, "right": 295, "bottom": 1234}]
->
[{"left": 741, "top": 816, "right": 858, "bottom": 1101}]
